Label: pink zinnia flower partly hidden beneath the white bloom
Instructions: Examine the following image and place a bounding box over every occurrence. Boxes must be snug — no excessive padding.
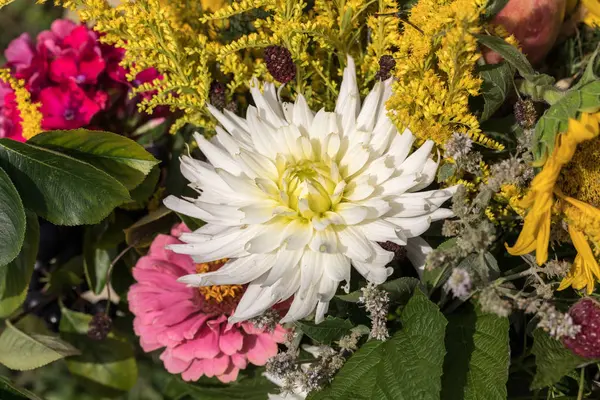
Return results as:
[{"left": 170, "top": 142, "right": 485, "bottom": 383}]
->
[{"left": 128, "top": 227, "right": 286, "bottom": 382}]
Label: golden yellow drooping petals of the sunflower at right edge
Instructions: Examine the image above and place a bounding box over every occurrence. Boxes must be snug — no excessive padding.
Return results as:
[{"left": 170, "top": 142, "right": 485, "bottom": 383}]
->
[{"left": 508, "top": 113, "right": 600, "bottom": 293}]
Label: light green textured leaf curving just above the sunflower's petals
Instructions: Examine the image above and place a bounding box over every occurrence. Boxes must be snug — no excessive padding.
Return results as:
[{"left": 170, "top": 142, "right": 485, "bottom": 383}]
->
[{"left": 534, "top": 80, "right": 600, "bottom": 162}]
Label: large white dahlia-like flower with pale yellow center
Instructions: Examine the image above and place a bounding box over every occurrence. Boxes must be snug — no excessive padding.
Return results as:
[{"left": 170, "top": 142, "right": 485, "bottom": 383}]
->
[{"left": 165, "top": 58, "right": 454, "bottom": 322}]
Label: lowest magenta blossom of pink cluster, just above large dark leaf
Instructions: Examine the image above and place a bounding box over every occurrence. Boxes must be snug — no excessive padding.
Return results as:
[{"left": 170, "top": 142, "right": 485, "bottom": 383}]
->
[{"left": 39, "top": 82, "right": 106, "bottom": 129}]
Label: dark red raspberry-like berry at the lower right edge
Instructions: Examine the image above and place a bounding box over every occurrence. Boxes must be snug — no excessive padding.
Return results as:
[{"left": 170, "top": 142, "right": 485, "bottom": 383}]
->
[{"left": 563, "top": 297, "right": 600, "bottom": 358}]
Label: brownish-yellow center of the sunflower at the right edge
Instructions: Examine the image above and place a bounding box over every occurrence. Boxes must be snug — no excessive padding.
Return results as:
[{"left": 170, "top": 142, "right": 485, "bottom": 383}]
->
[{"left": 558, "top": 136, "right": 600, "bottom": 207}]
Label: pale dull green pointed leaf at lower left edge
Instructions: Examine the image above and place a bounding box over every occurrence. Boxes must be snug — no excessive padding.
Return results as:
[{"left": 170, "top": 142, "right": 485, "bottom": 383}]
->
[{"left": 0, "top": 321, "right": 79, "bottom": 371}]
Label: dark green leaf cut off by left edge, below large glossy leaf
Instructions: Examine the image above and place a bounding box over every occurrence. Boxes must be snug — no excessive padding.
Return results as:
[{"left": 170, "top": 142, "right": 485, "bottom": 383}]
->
[{"left": 0, "top": 168, "right": 25, "bottom": 270}]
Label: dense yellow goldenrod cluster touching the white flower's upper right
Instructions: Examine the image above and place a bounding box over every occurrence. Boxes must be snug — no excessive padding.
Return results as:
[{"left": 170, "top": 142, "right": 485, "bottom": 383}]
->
[{"left": 388, "top": 0, "right": 503, "bottom": 150}]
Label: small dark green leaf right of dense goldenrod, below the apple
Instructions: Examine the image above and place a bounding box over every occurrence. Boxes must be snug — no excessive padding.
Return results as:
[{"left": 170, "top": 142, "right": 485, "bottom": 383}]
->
[{"left": 479, "top": 62, "right": 515, "bottom": 122}]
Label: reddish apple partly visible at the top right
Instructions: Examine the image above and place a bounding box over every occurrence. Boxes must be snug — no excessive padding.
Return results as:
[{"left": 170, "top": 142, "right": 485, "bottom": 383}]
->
[{"left": 483, "top": 0, "right": 567, "bottom": 64}]
